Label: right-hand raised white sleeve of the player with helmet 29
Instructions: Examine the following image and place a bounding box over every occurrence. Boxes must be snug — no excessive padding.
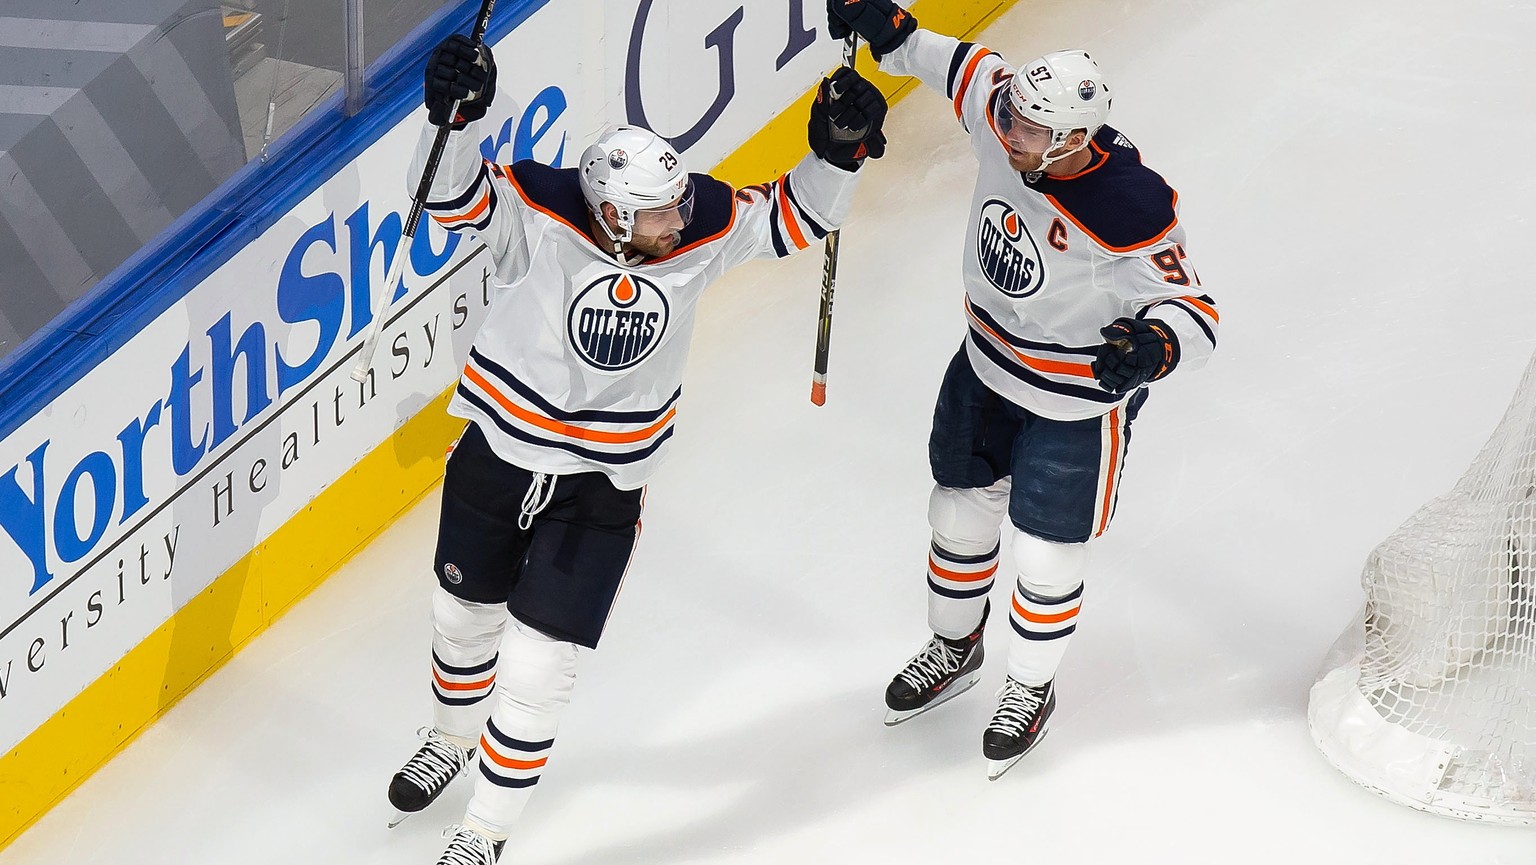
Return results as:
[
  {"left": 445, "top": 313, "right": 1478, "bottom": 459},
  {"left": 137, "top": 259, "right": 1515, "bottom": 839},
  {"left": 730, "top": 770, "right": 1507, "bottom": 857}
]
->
[{"left": 722, "top": 154, "right": 859, "bottom": 267}]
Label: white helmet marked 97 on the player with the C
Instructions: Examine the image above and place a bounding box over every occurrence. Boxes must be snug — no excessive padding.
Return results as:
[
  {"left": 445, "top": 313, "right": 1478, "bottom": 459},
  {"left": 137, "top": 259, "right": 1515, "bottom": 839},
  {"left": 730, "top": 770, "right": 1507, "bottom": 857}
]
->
[{"left": 992, "top": 49, "right": 1112, "bottom": 171}]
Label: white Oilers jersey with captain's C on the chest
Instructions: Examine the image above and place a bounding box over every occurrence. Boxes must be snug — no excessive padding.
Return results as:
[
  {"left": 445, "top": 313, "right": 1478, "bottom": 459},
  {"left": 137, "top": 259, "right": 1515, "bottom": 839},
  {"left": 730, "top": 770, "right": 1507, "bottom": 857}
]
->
[{"left": 880, "top": 29, "right": 1220, "bottom": 421}]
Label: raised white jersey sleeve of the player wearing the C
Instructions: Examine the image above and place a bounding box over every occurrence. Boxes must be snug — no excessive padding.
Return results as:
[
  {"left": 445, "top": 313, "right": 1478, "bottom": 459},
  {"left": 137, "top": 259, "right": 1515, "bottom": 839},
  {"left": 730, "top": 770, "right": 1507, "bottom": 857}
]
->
[{"left": 880, "top": 29, "right": 1014, "bottom": 132}]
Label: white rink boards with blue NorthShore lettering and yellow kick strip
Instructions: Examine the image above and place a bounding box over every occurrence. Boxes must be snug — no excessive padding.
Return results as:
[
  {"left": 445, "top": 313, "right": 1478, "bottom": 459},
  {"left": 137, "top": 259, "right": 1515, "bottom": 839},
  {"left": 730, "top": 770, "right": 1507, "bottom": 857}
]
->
[{"left": 0, "top": 0, "right": 1012, "bottom": 845}]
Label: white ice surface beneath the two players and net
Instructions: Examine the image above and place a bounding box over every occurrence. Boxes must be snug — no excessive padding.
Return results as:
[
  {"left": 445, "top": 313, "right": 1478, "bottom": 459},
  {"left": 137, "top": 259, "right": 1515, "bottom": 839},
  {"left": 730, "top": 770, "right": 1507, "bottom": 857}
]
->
[{"left": 12, "top": 0, "right": 1536, "bottom": 865}]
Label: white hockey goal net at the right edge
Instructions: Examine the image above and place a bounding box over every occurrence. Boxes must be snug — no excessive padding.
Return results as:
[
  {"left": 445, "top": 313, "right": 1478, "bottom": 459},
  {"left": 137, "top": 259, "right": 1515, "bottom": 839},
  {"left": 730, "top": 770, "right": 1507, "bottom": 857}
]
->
[{"left": 1309, "top": 358, "right": 1536, "bottom": 824}]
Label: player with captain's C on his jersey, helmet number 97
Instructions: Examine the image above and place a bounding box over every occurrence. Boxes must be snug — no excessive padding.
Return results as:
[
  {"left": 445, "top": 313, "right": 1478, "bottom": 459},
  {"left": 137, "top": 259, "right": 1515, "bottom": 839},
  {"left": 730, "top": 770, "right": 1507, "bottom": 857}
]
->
[{"left": 828, "top": 0, "right": 1218, "bottom": 777}]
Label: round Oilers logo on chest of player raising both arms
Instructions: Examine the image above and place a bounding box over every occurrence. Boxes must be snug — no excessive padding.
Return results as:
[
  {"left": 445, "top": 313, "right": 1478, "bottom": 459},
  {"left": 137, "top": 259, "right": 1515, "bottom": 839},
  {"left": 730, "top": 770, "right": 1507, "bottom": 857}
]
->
[{"left": 565, "top": 273, "right": 671, "bottom": 372}]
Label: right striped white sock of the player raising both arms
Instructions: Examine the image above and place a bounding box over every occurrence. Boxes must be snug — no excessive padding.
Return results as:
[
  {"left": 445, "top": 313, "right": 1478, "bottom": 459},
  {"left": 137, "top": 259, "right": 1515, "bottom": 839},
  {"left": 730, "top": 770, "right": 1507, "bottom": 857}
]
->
[{"left": 465, "top": 619, "right": 576, "bottom": 837}]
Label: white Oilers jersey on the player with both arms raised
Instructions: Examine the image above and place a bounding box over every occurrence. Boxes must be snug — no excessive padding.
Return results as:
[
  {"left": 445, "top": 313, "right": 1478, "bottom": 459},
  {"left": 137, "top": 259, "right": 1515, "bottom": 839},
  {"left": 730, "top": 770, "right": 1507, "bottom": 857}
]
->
[{"left": 407, "top": 123, "right": 857, "bottom": 489}]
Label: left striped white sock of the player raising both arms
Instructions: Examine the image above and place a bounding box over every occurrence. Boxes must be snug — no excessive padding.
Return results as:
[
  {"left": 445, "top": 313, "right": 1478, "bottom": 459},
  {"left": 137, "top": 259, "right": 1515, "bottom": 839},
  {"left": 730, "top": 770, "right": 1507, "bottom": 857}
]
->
[{"left": 432, "top": 585, "right": 508, "bottom": 747}]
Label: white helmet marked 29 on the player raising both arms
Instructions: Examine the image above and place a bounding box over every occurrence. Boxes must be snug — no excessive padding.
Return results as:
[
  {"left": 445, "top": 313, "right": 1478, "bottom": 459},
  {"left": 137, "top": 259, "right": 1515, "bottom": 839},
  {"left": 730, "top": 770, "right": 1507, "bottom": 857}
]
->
[{"left": 579, "top": 126, "right": 693, "bottom": 252}]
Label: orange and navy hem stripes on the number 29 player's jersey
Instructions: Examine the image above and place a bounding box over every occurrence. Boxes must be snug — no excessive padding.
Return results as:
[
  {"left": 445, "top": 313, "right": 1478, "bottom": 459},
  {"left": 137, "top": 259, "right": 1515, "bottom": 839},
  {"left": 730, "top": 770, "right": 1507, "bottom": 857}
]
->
[{"left": 458, "top": 347, "right": 682, "bottom": 466}]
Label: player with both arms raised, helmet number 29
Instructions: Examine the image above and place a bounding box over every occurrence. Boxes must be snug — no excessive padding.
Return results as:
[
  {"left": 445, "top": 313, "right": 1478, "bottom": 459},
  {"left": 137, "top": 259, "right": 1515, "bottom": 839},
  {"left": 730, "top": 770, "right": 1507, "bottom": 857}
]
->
[{"left": 389, "top": 37, "right": 886, "bottom": 865}]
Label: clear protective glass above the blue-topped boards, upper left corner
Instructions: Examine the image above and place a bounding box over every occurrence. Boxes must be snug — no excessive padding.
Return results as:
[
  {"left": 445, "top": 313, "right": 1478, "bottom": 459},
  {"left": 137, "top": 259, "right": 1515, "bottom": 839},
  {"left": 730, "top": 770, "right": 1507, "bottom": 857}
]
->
[{"left": 0, "top": 0, "right": 444, "bottom": 366}]
